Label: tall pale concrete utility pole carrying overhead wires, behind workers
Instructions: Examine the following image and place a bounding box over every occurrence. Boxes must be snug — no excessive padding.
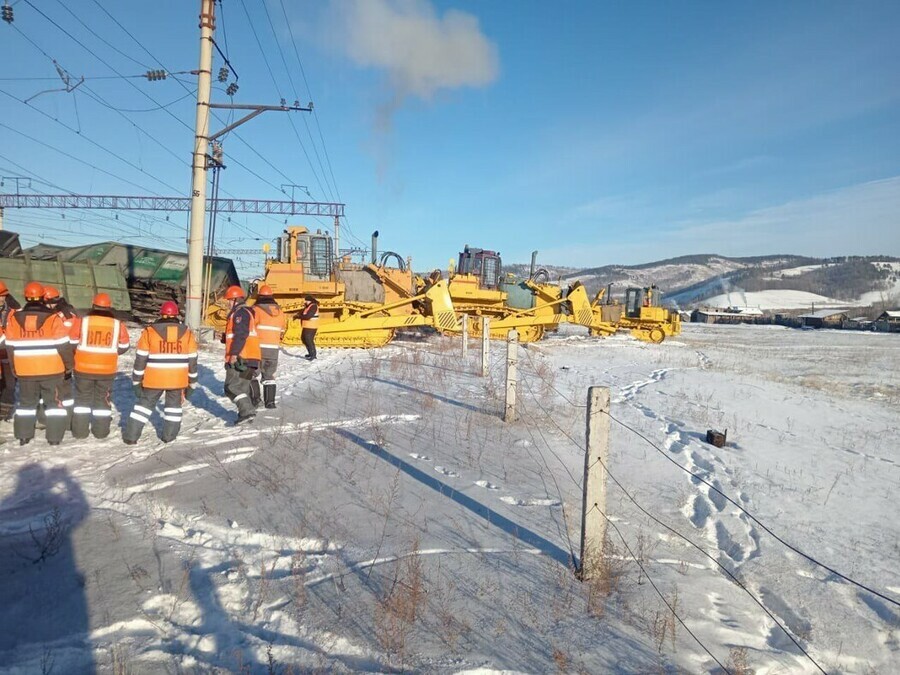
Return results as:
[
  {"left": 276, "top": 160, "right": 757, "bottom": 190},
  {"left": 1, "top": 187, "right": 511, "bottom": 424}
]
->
[{"left": 185, "top": 0, "right": 216, "bottom": 329}]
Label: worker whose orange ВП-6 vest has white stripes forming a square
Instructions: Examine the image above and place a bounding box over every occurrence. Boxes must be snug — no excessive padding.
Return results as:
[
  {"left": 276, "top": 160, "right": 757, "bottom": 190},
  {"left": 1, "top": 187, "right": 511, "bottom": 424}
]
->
[{"left": 71, "top": 293, "right": 131, "bottom": 438}]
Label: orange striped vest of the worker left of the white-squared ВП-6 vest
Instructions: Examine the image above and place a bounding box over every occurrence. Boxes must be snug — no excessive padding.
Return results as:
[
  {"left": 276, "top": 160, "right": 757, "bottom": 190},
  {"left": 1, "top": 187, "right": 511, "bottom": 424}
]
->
[{"left": 6, "top": 306, "right": 70, "bottom": 379}]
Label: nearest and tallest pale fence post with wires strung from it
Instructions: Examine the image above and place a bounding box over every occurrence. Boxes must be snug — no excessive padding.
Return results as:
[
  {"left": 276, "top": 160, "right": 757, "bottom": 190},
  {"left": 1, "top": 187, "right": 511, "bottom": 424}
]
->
[{"left": 580, "top": 387, "right": 609, "bottom": 579}]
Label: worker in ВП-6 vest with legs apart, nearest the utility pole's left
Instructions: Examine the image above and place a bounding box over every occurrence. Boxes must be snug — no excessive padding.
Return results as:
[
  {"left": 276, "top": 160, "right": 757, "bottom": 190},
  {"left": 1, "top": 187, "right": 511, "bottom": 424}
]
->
[{"left": 122, "top": 301, "right": 197, "bottom": 445}]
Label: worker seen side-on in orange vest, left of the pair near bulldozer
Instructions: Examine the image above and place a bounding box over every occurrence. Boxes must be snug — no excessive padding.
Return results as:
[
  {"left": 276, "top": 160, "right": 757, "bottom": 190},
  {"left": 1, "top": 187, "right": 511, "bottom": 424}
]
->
[{"left": 225, "top": 286, "right": 262, "bottom": 424}]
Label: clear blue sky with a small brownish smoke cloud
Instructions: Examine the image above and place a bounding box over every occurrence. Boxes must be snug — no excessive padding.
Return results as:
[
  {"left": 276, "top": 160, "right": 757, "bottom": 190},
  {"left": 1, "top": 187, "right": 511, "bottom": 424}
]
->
[{"left": 0, "top": 0, "right": 900, "bottom": 273}]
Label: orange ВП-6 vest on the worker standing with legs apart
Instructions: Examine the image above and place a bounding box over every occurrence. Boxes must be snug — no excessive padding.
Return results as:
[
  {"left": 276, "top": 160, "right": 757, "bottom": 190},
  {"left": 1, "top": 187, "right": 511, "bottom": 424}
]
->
[{"left": 133, "top": 321, "right": 197, "bottom": 389}]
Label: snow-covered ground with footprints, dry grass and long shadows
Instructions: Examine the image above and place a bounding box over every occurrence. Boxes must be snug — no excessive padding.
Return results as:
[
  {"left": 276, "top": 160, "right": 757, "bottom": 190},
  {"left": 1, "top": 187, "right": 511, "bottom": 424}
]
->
[{"left": 0, "top": 325, "right": 900, "bottom": 673}]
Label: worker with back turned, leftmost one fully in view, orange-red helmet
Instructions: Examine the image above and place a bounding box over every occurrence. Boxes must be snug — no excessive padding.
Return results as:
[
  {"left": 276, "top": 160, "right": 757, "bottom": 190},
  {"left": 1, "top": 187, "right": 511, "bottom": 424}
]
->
[{"left": 6, "top": 282, "right": 74, "bottom": 445}]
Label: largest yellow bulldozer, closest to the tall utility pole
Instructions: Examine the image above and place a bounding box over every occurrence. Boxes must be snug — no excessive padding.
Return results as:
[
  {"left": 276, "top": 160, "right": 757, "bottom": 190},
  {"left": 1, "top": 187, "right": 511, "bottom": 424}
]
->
[{"left": 206, "top": 226, "right": 457, "bottom": 348}]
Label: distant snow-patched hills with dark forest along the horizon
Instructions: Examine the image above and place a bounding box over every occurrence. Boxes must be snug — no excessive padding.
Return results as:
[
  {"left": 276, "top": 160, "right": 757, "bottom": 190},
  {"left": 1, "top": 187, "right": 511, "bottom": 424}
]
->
[{"left": 504, "top": 254, "right": 900, "bottom": 309}]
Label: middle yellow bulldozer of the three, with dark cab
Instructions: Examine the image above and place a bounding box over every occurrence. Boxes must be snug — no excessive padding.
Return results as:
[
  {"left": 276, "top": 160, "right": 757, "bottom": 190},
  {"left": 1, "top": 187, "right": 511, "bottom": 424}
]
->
[{"left": 428, "top": 246, "right": 616, "bottom": 342}]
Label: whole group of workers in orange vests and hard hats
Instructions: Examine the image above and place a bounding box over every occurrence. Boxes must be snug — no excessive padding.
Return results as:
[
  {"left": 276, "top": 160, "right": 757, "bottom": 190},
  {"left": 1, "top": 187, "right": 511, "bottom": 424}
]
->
[{"left": 0, "top": 281, "right": 319, "bottom": 445}]
